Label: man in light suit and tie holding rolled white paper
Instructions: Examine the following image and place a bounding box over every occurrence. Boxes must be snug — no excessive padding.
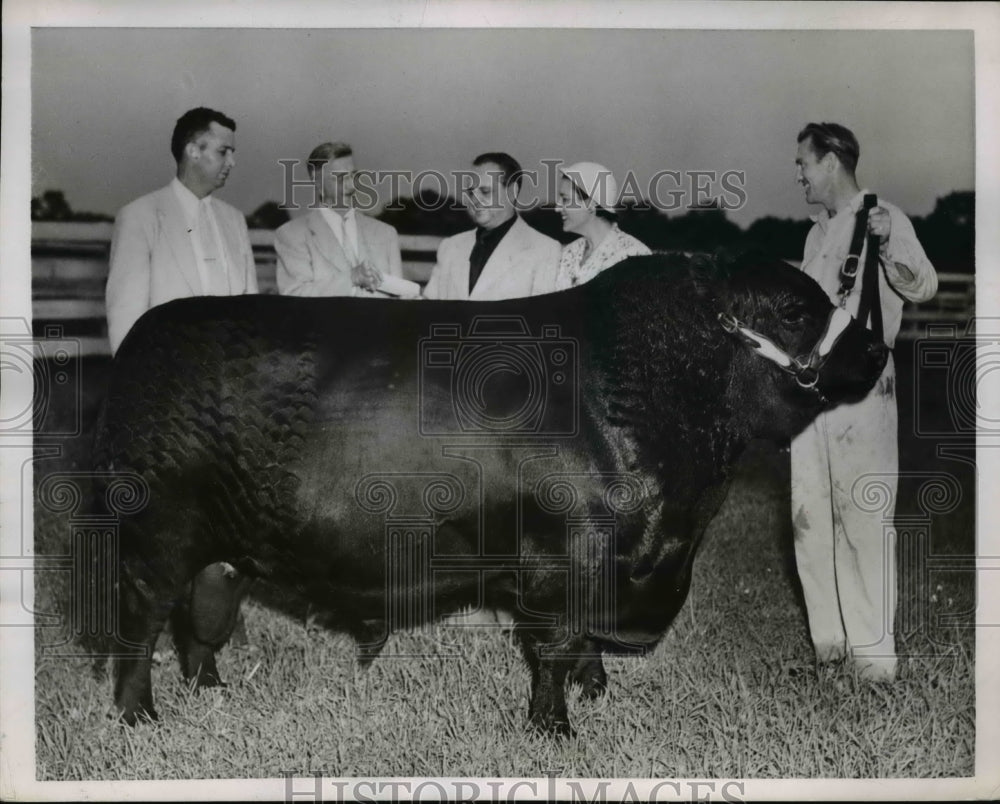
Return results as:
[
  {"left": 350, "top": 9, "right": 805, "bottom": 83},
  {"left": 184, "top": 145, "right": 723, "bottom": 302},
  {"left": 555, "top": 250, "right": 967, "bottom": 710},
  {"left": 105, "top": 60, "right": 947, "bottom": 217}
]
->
[{"left": 274, "top": 142, "right": 403, "bottom": 296}]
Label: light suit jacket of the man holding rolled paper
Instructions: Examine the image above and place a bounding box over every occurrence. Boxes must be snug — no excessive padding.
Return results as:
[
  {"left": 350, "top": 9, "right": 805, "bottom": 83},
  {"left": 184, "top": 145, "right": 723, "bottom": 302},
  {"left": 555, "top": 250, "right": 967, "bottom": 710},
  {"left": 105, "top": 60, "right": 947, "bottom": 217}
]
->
[{"left": 274, "top": 209, "right": 403, "bottom": 296}]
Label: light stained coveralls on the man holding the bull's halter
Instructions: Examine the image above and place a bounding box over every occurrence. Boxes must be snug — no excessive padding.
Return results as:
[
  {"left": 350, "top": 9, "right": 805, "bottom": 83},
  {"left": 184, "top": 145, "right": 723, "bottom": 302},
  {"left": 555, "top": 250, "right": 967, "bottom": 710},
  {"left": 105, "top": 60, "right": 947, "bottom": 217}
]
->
[{"left": 791, "top": 190, "right": 937, "bottom": 680}]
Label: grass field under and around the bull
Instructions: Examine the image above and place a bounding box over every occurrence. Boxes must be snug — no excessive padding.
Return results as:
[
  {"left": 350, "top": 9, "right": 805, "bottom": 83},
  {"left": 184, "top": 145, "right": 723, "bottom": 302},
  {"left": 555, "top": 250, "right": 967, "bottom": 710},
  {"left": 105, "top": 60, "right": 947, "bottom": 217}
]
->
[{"left": 35, "top": 344, "right": 975, "bottom": 780}]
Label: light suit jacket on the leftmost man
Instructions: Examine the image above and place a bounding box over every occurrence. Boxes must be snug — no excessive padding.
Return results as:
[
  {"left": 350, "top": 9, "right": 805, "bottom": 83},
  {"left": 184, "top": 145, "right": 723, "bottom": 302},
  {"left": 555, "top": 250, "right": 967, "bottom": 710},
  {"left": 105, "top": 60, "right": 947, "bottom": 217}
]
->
[{"left": 105, "top": 184, "right": 257, "bottom": 354}]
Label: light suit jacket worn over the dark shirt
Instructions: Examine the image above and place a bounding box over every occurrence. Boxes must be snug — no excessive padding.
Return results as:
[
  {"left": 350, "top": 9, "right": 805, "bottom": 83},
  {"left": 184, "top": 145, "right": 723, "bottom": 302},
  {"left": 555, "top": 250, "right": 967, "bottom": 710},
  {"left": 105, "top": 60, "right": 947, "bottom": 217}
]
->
[{"left": 424, "top": 217, "right": 562, "bottom": 301}]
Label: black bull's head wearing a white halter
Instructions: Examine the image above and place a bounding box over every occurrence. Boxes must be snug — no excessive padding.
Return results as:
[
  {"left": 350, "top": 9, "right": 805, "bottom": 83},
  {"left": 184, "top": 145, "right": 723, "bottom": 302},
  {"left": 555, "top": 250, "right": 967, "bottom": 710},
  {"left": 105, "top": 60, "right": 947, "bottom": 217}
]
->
[{"left": 718, "top": 259, "right": 889, "bottom": 437}]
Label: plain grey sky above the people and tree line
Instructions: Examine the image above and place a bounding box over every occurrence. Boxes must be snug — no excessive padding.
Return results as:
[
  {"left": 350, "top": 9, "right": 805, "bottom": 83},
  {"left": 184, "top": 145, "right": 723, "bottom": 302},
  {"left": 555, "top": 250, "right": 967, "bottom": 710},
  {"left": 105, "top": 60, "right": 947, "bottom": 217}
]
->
[{"left": 31, "top": 28, "right": 975, "bottom": 225}]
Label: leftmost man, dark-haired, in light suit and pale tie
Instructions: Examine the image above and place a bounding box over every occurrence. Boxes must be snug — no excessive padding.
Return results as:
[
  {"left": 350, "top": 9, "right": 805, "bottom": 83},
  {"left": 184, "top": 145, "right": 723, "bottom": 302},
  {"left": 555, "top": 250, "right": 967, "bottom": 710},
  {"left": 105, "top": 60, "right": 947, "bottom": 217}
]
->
[{"left": 105, "top": 107, "right": 257, "bottom": 354}]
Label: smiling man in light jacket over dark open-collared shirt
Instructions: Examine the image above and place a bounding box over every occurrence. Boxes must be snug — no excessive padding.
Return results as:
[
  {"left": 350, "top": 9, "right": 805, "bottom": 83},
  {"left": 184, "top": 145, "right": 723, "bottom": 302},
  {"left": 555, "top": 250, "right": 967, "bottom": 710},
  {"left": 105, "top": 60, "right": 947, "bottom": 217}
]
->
[{"left": 424, "top": 153, "right": 561, "bottom": 301}]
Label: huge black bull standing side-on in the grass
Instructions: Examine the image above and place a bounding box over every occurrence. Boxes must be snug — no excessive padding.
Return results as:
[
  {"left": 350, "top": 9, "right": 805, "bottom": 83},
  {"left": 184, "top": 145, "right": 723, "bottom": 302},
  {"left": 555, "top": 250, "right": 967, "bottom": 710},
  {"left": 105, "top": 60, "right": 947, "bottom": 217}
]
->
[{"left": 95, "top": 255, "right": 886, "bottom": 733}]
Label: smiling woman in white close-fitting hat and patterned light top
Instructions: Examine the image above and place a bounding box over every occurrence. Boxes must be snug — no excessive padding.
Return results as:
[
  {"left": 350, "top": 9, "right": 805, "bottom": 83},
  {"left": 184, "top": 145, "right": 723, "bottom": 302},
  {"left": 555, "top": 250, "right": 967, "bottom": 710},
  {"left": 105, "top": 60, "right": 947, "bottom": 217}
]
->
[{"left": 556, "top": 162, "right": 652, "bottom": 290}]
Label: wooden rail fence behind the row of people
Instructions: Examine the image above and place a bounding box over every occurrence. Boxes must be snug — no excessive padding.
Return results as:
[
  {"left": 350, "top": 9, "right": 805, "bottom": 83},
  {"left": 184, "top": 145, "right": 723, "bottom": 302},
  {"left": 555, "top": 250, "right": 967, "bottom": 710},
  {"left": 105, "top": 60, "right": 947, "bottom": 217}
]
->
[{"left": 31, "top": 221, "right": 976, "bottom": 356}]
